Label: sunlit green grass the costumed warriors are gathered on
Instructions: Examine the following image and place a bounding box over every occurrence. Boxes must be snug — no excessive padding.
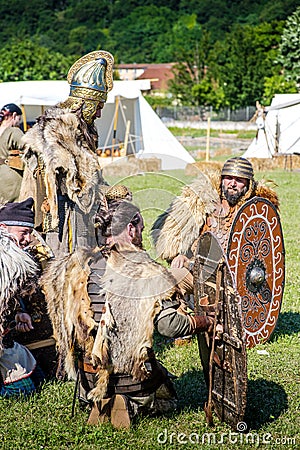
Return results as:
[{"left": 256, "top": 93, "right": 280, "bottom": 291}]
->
[{"left": 0, "top": 171, "right": 300, "bottom": 450}]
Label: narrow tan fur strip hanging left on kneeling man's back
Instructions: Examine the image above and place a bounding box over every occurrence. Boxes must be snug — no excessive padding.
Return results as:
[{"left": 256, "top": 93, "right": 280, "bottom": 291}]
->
[{"left": 40, "top": 249, "right": 96, "bottom": 379}]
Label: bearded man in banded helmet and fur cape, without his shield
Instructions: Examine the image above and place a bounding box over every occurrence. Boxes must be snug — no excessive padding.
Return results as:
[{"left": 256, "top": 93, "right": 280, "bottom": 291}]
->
[{"left": 152, "top": 157, "right": 279, "bottom": 276}]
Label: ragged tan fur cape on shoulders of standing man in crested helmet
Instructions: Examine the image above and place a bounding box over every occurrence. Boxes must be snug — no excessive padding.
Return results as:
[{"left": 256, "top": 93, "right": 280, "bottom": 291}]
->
[{"left": 20, "top": 106, "right": 100, "bottom": 228}]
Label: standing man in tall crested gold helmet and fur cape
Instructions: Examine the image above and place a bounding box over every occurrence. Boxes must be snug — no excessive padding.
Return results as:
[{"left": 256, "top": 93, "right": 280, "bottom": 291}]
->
[{"left": 20, "top": 50, "right": 114, "bottom": 254}]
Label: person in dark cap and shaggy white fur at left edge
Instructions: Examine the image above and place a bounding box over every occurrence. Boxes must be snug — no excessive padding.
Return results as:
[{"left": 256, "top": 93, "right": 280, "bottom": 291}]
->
[{"left": 0, "top": 198, "right": 44, "bottom": 397}]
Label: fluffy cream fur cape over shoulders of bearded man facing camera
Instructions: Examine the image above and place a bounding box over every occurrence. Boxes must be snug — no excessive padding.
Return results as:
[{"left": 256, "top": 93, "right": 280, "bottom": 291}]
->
[{"left": 151, "top": 172, "right": 279, "bottom": 260}]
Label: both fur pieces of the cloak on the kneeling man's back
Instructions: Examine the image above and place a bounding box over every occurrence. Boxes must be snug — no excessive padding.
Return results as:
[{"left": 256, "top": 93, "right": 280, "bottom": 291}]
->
[{"left": 42, "top": 246, "right": 177, "bottom": 400}]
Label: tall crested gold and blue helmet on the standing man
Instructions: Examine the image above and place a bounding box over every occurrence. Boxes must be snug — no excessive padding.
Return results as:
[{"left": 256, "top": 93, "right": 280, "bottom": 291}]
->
[{"left": 62, "top": 50, "right": 114, "bottom": 124}]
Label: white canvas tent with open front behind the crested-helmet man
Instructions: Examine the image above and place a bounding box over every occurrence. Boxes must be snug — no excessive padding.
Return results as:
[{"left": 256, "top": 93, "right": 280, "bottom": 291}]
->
[{"left": 0, "top": 80, "right": 194, "bottom": 170}]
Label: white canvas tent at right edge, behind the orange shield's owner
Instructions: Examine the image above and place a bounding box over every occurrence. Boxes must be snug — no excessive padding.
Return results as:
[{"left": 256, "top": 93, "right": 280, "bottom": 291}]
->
[{"left": 243, "top": 94, "right": 300, "bottom": 158}]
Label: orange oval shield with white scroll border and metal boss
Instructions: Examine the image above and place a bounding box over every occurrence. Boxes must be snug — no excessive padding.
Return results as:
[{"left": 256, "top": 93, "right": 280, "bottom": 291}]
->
[{"left": 227, "top": 197, "right": 285, "bottom": 348}]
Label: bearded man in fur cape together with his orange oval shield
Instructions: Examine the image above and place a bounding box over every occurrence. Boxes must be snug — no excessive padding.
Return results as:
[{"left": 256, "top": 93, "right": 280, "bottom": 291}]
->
[{"left": 152, "top": 157, "right": 284, "bottom": 346}]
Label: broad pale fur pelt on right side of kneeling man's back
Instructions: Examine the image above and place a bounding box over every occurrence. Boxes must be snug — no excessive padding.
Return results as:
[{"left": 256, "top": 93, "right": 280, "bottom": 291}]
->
[{"left": 90, "top": 245, "right": 177, "bottom": 400}]
